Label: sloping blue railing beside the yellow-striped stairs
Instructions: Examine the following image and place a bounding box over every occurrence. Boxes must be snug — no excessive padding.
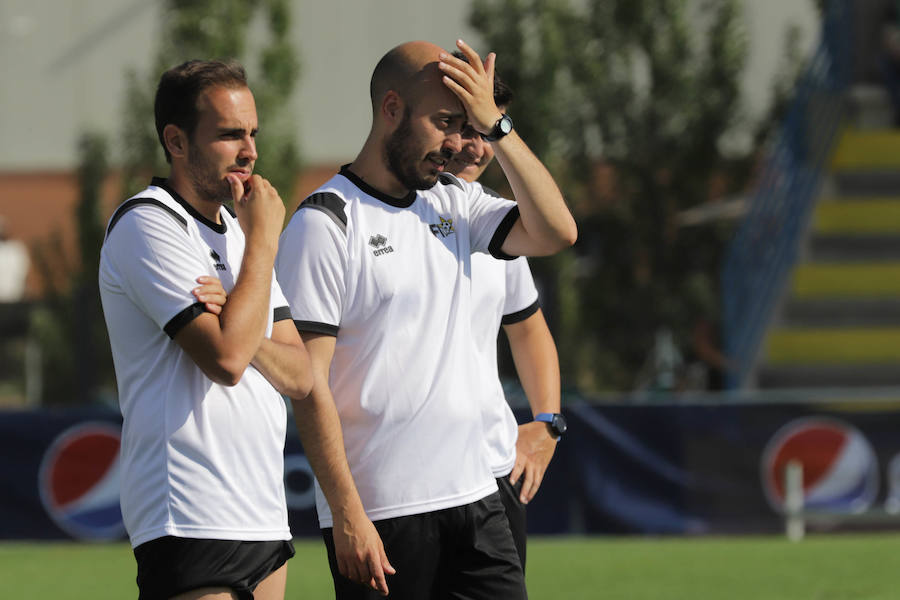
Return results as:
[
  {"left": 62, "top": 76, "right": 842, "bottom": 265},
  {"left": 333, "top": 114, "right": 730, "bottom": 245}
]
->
[{"left": 722, "top": 0, "right": 855, "bottom": 389}]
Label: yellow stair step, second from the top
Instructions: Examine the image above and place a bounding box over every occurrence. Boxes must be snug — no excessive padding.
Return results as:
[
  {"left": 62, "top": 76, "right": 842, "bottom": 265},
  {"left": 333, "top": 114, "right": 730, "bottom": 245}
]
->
[{"left": 813, "top": 197, "right": 900, "bottom": 234}]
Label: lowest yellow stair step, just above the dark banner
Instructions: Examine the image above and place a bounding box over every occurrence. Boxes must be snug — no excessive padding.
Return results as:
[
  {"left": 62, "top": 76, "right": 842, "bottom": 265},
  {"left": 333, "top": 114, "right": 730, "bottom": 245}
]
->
[{"left": 766, "top": 328, "right": 900, "bottom": 369}]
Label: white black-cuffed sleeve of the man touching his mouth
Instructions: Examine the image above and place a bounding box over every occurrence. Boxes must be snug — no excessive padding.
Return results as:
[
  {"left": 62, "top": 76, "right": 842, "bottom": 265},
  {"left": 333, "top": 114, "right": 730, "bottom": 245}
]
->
[{"left": 104, "top": 206, "right": 211, "bottom": 337}]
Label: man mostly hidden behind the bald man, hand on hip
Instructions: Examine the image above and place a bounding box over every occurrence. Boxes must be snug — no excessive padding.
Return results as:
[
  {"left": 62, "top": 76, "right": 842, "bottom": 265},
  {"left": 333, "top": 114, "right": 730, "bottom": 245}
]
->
[{"left": 447, "top": 57, "right": 565, "bottom": 570}]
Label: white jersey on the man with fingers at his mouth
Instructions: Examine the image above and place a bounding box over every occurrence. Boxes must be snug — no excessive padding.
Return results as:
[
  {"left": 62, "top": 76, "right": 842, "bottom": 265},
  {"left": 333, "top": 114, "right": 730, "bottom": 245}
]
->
[{"left": 100, "top": 179, "right": 291, "bottom": 546}]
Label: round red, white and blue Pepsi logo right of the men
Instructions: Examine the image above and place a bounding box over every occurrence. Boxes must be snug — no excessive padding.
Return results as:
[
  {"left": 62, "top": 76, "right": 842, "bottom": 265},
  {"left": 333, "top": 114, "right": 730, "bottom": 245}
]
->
[{"left": 761, "top": 417, "right": 879, "bottom": 514}]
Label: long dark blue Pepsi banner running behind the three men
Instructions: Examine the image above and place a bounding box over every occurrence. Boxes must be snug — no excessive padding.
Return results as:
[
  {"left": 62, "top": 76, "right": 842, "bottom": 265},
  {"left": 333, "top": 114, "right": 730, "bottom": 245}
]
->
[{"left": 0, "top": 402, "right": 900, "bottom": 540}]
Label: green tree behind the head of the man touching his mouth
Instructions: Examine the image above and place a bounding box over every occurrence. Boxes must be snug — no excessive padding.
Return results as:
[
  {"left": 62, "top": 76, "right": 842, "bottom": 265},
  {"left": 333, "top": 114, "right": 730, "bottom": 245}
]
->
[{"left": 123, "top": 0, "right": 300, "bottom": 202}]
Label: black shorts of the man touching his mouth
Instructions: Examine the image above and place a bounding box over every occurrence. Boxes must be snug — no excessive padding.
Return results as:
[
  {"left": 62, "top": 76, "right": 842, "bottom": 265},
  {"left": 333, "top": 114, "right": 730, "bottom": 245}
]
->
[{"left": 134, "top": 536, "right": 294, "bottom": 600}]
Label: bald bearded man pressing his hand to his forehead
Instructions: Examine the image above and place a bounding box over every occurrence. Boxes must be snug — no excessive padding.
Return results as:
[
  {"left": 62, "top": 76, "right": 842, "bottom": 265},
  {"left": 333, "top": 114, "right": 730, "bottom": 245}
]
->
[{"left": 276, "top": 41, "right": 577, "bottom": 600}]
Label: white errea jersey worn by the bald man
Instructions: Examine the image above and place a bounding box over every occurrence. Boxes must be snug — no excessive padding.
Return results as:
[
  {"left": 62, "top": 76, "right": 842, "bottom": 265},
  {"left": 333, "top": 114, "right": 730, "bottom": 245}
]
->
[{"left": 275, "top": 168, "right": 518, "bottom": 527}]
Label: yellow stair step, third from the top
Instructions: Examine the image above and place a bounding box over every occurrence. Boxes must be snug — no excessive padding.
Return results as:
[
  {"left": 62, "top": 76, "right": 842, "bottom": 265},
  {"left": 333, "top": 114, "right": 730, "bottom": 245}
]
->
[{"left": 791, "top": 262, "right": 900, "bottom": 302}]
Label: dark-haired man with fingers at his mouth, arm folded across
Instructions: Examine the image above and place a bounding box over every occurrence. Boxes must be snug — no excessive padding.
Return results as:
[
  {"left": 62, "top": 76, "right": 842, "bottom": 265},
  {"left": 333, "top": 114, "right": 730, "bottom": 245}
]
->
[{"left": 99, "top": 60, "right": 312, "bottom": 600}]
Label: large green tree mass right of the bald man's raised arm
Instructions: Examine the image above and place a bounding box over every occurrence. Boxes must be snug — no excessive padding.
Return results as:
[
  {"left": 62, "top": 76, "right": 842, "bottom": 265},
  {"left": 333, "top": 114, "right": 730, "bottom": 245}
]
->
[{"left": 470, "top": 0, "right": 792, "bottom": 390}]
